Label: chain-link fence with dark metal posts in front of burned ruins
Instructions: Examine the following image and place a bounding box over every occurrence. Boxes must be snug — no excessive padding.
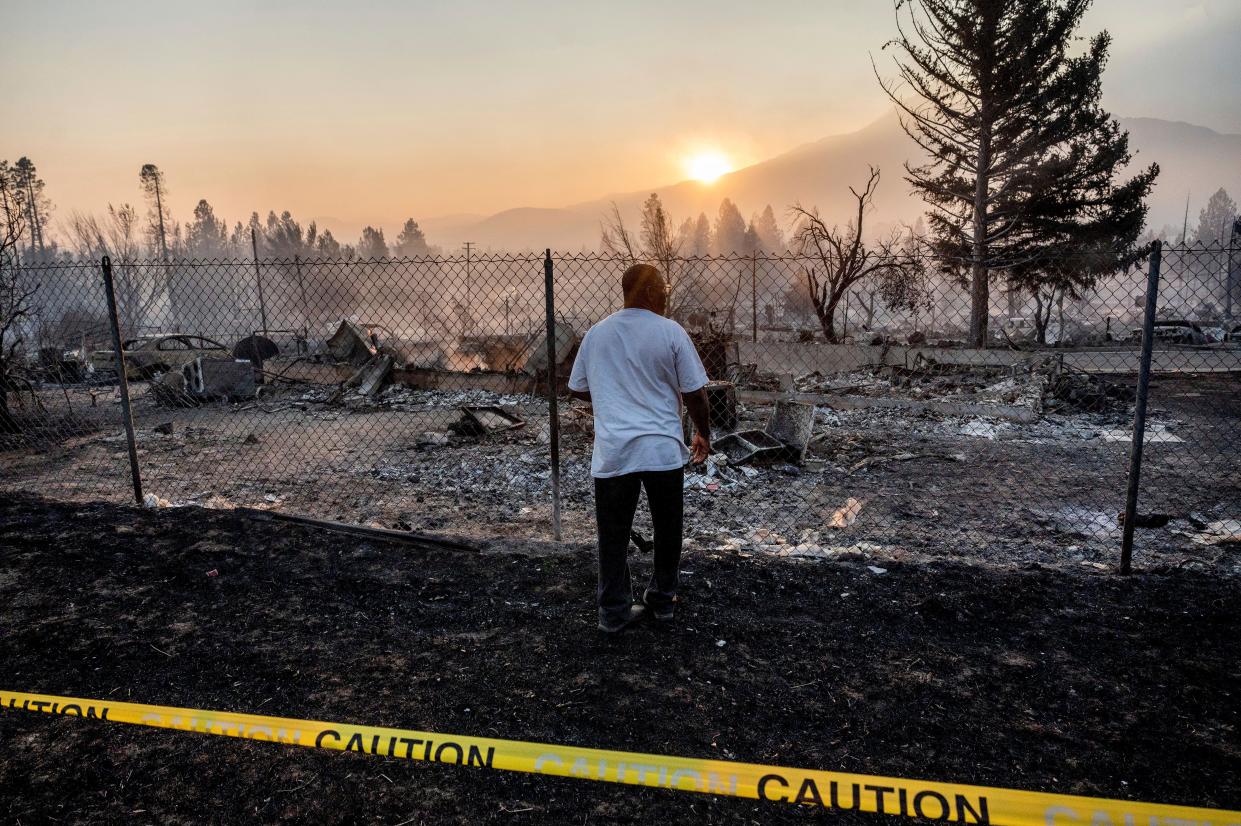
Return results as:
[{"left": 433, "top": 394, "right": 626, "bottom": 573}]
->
[{"left": 0, "top": 246, "right": 1241, "bottom": 568}]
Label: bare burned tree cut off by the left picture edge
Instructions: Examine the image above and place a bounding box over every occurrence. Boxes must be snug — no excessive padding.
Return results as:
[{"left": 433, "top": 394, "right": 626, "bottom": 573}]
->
[{"left": 0, "top": 166, "right": 38, "bottom": 433}]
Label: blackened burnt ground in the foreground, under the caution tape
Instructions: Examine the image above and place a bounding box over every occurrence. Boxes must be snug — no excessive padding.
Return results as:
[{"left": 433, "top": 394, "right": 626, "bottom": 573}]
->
[{"left": 0, "top": 494, "right": 1241, "bottom": 826}]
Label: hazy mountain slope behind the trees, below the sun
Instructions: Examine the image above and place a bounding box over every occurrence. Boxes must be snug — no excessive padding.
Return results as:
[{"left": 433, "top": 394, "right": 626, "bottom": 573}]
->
[{"left": 423, "top": 113, "right": 1241, "bottom": 251}]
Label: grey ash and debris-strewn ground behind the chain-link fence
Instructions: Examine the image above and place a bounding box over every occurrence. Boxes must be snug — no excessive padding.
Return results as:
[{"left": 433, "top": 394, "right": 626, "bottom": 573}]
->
[{"left": 0, "top": 359, "right": 1241, "bottom": 573}]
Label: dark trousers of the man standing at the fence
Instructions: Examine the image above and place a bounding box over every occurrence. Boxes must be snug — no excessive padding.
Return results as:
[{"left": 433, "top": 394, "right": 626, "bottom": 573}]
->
[{"left": 594, "top": 468, "right": 685, "bottom": 620}]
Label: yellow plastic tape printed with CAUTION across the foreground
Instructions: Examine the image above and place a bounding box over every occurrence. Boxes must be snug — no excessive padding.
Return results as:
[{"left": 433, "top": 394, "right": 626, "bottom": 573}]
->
[{"left": 0, "top": 691, "right": 1241, "bottom": 826}]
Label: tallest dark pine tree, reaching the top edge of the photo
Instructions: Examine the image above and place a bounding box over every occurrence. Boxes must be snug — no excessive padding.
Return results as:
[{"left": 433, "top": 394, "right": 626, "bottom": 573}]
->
[{"left": 880, "top": 0, "right": 1159, "bottom": 346}]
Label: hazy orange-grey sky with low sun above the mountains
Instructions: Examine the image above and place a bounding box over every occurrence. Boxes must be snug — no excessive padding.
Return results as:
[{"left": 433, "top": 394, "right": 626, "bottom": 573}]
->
[{"left": 0, "top": 0, "right": 1241, "bottom": 241}]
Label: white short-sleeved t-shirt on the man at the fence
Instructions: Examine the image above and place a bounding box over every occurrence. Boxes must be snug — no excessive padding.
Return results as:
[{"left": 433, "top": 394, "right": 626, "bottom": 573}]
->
[{"left": 568, "top": 308, "right": 707, "bottom": 479}]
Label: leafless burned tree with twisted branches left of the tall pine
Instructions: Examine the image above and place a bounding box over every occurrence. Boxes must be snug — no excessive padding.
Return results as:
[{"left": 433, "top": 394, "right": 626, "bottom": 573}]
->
[{"left": 792, "top": 166, "right": 921, "bottom": 344}]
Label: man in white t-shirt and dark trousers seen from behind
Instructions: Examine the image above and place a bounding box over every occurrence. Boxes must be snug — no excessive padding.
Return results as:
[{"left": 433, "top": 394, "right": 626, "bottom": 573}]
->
[{"left": 568, "top": 264, "right": 711, "bottom": 634}]
